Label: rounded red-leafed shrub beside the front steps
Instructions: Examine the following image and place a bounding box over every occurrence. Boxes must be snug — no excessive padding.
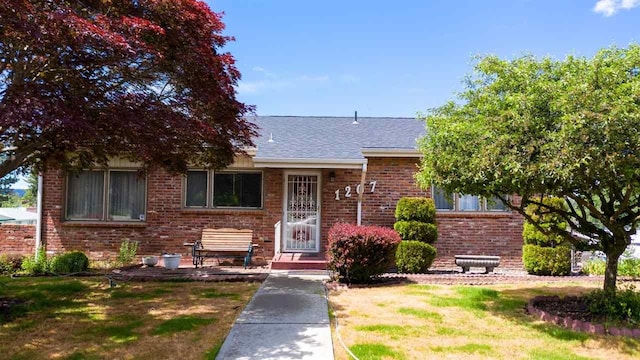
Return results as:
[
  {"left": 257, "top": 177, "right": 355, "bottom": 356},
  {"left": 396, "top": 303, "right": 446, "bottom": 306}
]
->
[{"left": 327, "top": 223, "right": 400, "bottom": 284}]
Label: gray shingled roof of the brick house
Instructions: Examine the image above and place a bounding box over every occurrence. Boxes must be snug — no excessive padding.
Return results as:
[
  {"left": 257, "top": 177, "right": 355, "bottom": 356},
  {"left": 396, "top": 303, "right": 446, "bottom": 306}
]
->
[{"left": 248, "top": 116, "right": 425, "bottom": 160}]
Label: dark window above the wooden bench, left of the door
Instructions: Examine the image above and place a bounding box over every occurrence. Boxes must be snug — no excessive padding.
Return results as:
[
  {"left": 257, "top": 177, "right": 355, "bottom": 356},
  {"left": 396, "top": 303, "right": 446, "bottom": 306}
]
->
[{"left": 184, "top": 170, "right": 262, "bottom": 209}]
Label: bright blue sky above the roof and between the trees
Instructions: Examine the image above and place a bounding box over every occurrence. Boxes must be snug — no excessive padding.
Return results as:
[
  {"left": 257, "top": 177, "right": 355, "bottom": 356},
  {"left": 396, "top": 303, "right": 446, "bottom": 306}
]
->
[{"left": 207, "top": 0, "right": 640, "bottom": 116}]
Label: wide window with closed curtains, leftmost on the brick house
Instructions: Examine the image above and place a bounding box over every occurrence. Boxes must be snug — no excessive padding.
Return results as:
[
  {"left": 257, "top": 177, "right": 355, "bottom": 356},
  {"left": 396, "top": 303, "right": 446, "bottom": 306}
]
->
[{"left": 65, "top": 170, "right": 147, "bottom": 221}]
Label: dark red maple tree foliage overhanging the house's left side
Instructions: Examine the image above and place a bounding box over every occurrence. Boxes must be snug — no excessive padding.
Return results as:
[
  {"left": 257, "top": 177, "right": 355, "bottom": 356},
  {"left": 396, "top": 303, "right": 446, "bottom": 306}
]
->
[{"left": 0, "top": 0, "right": 255, "bottom": 178}]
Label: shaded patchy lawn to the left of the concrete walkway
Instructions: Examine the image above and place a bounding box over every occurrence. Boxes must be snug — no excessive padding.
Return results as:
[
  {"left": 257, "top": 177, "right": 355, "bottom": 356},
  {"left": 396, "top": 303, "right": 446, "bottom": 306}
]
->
[{"left": 0, "top": 277, "right": 259, "bottom": 359}]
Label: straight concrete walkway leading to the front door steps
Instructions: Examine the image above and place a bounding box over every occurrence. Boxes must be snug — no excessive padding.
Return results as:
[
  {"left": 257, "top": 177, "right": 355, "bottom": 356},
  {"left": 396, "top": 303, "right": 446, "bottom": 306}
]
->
[{"left": 216, "top": 273, "right": 333, "bottom": 360}]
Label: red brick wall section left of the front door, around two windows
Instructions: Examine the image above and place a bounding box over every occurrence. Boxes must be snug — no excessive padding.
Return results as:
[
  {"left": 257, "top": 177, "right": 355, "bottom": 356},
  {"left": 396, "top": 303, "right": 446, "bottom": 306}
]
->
[{"left": 43, "top": 169, "right": 282, "bottom": 259}]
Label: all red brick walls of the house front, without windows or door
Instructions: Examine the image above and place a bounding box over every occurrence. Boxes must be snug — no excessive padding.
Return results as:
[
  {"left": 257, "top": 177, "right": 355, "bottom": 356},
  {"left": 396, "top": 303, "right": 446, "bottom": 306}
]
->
[{"left": 17, "top": 158, "right": 522, "bottom": 268}]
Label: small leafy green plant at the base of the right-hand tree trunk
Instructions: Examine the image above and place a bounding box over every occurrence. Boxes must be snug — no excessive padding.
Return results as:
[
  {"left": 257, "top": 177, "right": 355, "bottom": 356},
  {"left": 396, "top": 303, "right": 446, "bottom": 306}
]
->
[{"left": 585, "top": 285, "right": 640, "bottom": 325}]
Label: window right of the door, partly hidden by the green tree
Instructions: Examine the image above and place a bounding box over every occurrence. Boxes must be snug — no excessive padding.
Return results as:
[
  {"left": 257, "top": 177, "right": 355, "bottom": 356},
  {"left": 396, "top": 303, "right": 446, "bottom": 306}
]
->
[{"left": 431, "top": 186, "right": 509, "bottom": 212}]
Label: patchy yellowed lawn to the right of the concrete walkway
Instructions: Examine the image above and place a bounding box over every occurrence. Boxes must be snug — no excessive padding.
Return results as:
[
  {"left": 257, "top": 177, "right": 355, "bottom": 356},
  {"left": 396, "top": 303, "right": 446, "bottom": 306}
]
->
[{"left": 329, "top": 283, "right": 640, "bottom": 360}]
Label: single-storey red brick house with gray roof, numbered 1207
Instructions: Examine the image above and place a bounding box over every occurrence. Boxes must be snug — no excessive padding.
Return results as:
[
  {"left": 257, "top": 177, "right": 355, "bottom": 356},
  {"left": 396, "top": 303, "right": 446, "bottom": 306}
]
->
[{"left": 28, "top": 116, "right": 522, "bottom": 268}]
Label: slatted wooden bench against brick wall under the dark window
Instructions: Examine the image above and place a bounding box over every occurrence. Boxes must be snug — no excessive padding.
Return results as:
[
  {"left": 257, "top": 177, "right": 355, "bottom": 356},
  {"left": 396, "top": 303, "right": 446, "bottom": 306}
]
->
[{"left": 192, "top": 229, "right": 253, "bottom": 269}]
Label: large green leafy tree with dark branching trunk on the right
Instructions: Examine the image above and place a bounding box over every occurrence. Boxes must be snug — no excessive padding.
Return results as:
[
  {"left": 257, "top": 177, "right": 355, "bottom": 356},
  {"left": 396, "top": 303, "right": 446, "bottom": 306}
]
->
[{"left": 417, "top": 45, "right": 640, "bottom": 292}]
